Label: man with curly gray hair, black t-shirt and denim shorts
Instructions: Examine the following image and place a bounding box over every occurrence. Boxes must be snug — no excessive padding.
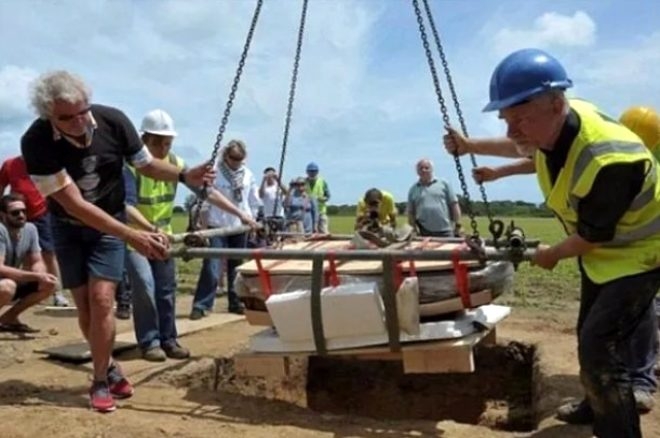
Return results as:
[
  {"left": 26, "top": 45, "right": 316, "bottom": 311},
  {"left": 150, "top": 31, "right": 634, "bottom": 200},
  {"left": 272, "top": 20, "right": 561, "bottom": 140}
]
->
[{"left": 21, "top": 71, "right": 215, "bottom": 412}]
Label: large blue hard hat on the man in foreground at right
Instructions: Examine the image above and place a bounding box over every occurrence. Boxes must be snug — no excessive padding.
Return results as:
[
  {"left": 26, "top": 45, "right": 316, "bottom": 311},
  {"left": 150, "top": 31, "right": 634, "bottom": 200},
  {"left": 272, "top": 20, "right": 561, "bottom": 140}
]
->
[{"left": 483, "top": 49, "right": 573, "bottom": 111}]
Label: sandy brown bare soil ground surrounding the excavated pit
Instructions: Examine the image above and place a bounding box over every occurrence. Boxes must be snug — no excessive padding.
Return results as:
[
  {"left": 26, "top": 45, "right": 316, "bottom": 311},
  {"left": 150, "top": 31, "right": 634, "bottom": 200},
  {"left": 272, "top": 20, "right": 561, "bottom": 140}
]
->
[{"left": 0, "top": 297, "right": 660, "bottom": 438}]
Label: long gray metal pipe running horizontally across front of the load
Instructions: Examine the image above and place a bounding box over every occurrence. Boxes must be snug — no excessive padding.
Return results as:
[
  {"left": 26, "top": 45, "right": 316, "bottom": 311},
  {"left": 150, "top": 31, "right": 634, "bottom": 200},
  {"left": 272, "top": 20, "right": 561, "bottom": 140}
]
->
[{"left": 170, "top": 247, "right": 536, "bottom": 261}]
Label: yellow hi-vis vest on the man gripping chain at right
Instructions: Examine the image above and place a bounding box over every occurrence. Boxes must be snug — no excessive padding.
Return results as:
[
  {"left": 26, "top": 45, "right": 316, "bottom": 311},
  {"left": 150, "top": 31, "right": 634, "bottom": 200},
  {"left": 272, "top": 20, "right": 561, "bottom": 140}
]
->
[{"left": 535, "top": 100, "right": 660, "bottom": 284}]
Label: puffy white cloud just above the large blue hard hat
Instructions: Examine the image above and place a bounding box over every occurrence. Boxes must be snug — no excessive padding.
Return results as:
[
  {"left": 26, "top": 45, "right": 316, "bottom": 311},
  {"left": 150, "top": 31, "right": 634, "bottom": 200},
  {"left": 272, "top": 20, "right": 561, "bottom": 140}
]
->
[{"left": 493, "top": 11, "right": 596, "bottom": 55}]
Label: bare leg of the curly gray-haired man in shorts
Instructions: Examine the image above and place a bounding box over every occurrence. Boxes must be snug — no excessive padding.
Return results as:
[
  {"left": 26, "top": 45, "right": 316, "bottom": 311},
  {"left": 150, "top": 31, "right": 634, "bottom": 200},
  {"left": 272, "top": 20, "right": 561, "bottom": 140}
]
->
[{"left": 87, "top": 277, "right": 117, "bottom": 381}]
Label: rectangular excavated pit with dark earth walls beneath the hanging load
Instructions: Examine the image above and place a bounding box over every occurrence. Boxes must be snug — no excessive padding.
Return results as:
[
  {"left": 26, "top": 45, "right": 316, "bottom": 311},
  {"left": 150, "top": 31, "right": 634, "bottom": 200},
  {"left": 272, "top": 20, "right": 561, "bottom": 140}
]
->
[{"left": 177, "top": 342, "right": 541, "bottom": 431}]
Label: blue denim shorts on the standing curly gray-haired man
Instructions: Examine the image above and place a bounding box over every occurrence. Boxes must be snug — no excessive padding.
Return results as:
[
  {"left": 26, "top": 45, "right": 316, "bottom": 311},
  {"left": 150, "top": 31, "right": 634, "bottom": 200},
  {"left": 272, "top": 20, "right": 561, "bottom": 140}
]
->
[{"left": 52, "top": 216, "right": 126, "bottom": 289}]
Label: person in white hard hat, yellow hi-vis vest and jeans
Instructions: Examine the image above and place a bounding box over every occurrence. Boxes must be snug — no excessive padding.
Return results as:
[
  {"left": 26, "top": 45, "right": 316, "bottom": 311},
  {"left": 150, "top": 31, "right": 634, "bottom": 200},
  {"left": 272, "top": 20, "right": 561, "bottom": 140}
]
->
[{"left": 124, "top": 109, "right": 256, "bottom": 362}]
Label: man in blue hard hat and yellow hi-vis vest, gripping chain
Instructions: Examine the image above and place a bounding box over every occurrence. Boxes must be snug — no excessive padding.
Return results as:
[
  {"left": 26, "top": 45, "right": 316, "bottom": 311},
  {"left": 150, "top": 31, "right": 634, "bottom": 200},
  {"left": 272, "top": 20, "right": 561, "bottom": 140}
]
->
[{"left": 445, "top": 49, "right": 660, "bottom": 438}]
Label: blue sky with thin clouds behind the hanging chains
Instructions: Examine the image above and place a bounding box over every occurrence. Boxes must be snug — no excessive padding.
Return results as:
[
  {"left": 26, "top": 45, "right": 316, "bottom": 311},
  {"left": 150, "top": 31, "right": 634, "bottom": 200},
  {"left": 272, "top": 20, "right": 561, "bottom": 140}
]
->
[{"left": 0, "top": 0, "right": 660, "bottom": 203}]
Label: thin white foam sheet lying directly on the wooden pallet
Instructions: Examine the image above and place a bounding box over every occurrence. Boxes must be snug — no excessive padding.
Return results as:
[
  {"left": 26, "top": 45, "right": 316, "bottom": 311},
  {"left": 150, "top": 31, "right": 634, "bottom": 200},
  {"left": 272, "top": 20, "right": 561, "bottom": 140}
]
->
[{"left": 250, "top": 304, "right": 511, "bottom": 353}]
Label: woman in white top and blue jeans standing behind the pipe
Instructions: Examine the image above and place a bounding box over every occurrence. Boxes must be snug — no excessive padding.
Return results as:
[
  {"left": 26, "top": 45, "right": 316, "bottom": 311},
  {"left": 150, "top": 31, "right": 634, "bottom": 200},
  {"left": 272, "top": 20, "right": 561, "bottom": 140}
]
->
[{"left": 190, "top": 140, "right": 261, "bottom": 319}]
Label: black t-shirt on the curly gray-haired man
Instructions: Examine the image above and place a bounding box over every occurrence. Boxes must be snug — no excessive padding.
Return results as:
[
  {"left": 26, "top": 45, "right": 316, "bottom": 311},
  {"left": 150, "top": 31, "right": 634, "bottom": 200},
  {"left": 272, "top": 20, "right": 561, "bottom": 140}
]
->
[{"left": 21, "top": 105, "right": 143, "bottom": 217}]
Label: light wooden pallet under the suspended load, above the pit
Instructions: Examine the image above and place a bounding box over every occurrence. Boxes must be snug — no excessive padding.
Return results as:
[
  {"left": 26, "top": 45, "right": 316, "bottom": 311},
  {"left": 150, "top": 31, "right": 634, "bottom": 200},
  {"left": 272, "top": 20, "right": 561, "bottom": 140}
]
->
[{"left": 234, "top": 327, "right": 497, "bottom": 377}]
